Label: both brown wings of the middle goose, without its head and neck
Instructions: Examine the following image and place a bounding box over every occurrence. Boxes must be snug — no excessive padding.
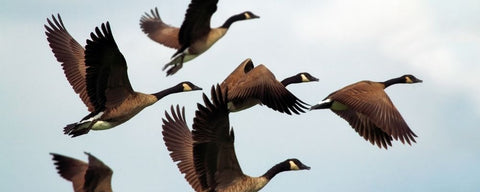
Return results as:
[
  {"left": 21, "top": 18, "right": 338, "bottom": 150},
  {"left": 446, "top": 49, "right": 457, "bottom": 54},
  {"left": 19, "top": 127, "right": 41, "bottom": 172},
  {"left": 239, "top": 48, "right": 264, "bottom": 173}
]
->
[{"left": 221, "top": 59, "right": 308, "bottom": 114}]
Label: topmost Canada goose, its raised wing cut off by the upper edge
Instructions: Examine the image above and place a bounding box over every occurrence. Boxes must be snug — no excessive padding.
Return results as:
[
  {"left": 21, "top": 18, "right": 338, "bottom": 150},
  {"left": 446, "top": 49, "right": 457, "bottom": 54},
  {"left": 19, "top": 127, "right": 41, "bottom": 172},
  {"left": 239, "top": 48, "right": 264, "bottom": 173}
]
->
[{"left": 140, "top": 0, "right": 260, "bottom": 76}]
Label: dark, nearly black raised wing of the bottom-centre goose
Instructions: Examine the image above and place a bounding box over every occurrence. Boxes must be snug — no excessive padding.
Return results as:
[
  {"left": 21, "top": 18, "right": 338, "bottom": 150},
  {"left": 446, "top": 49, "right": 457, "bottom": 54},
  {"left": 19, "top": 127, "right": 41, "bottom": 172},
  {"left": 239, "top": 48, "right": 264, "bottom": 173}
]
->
[{"left": 192, "top": 85, "right": 243, "bottom": 191}]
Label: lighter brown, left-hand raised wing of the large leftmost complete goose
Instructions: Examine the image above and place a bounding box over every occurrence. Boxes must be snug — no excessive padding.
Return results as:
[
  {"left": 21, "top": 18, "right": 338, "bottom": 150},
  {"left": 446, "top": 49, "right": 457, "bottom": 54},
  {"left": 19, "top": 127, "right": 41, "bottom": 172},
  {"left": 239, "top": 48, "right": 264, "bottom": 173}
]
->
[{"left": 45, "top": 15, "right": 94, "bottom": 112}]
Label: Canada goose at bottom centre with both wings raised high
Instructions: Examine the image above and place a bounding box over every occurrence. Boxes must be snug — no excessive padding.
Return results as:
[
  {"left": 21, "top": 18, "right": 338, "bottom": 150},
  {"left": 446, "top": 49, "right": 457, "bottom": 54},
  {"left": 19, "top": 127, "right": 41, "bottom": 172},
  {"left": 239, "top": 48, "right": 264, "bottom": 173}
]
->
[{"left": 162, "top": 85, "right": 310, "bottom": 192}]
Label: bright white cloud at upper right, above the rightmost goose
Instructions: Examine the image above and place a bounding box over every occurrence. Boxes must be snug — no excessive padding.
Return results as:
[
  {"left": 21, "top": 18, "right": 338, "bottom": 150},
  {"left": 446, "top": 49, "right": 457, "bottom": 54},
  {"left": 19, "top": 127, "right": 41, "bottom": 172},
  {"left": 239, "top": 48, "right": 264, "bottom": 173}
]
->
[{"left": 296, "top": 0, "right": 480, "bottom": 112}]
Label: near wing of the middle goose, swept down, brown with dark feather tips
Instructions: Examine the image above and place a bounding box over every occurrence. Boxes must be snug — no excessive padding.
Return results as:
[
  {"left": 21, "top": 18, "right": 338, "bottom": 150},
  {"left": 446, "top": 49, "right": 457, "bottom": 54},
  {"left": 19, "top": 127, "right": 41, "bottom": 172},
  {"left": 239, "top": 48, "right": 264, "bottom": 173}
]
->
[{"left": 226, "top": 65, "right": 307, "bottom": 114}]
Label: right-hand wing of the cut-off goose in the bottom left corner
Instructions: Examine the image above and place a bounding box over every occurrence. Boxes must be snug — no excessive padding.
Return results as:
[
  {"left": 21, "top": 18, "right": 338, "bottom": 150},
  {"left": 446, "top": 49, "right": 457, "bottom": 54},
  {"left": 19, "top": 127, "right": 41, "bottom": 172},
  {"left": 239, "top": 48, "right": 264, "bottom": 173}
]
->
[{"left": 83, "top": 153, "right": 113, "bottom": 192}]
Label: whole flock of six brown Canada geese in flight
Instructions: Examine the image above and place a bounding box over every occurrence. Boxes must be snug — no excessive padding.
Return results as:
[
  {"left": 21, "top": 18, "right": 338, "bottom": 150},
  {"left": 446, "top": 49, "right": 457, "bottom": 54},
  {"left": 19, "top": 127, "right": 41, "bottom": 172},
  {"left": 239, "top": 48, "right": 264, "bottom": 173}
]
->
[{"left": 45, "top": 0, "right": 422, "bottom": 192}]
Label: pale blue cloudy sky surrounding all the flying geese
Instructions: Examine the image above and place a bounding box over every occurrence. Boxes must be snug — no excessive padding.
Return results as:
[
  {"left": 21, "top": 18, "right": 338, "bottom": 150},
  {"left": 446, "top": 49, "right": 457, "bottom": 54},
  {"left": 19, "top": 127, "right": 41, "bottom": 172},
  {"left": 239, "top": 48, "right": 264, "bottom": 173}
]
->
[{"left": 0, "top": 0, "right": 480, "bottom": 191}]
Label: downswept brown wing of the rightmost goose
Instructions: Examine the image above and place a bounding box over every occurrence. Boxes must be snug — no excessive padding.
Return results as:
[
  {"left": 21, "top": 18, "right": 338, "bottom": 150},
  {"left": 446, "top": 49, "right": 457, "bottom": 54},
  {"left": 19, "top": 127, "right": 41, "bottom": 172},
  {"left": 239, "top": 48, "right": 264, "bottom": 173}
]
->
[{"left": 330, "top": 81, "right": 416, "bottom": 148}]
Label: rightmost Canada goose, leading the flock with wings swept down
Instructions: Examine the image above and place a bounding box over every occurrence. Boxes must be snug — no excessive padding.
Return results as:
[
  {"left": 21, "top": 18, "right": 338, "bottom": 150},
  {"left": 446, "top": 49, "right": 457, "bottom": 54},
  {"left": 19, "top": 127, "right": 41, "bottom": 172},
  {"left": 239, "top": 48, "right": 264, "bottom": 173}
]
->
[{"left": 311, "top": 75, "right": 422, "bottom": 149}]
